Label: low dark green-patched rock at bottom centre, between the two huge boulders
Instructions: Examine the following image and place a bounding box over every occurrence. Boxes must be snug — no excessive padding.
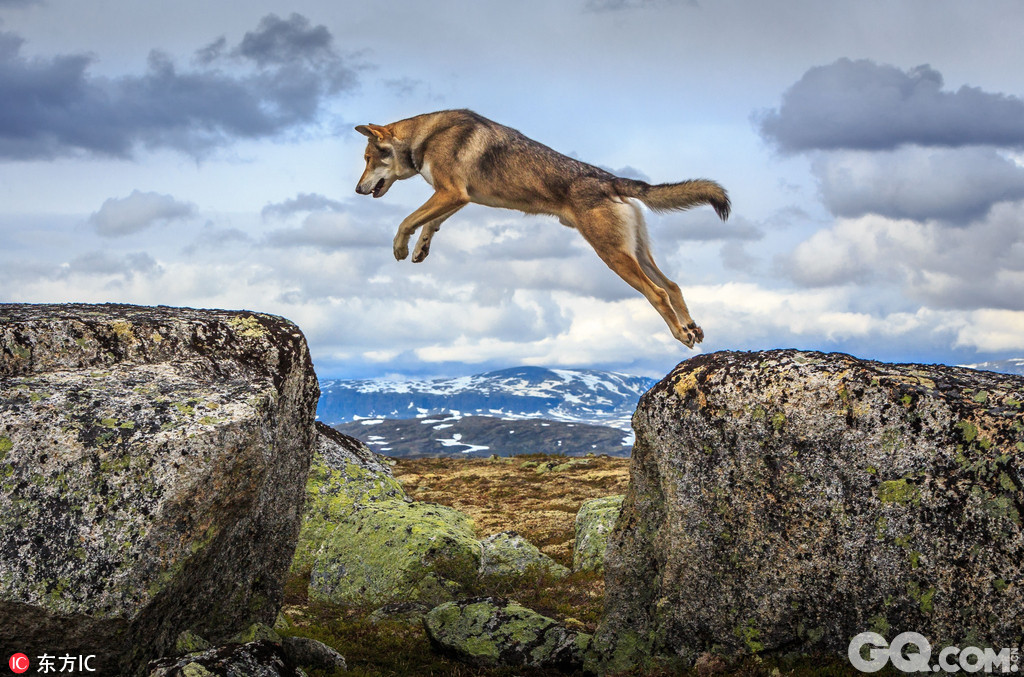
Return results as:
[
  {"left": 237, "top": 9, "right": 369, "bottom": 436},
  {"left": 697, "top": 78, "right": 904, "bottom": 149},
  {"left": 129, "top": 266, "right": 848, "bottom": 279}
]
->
[{"left": 424, "top": 597, "right": 591, "bottom": 670}]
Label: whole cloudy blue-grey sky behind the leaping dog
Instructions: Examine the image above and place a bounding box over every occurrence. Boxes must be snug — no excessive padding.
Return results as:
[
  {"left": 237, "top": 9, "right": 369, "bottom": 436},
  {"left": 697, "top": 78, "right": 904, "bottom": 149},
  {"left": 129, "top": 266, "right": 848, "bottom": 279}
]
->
[{"left": 0, "top": 0, "right": 1024, "bottom": 378}]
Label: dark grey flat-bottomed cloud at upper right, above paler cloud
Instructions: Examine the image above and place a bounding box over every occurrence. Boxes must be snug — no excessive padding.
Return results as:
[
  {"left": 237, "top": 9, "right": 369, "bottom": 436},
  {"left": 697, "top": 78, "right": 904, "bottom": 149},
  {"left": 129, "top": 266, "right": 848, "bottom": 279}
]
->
[{"left": 755, "top": 58, "right": 1024, "bottom": 153}]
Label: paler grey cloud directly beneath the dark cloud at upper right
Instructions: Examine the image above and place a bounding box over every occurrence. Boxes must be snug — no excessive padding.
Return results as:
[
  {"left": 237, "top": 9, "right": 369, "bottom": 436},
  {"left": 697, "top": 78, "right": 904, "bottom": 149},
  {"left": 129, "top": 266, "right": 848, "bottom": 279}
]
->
[{"left": 812, "top": 147, "right": 1024, "bottom": 224}]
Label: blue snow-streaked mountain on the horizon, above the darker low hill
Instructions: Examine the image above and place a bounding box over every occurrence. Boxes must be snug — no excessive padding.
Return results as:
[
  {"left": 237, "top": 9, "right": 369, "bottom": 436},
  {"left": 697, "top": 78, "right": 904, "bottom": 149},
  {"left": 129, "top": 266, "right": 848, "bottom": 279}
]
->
[{"left": 316, "top": 367, "right": 654, "bottom": 430}]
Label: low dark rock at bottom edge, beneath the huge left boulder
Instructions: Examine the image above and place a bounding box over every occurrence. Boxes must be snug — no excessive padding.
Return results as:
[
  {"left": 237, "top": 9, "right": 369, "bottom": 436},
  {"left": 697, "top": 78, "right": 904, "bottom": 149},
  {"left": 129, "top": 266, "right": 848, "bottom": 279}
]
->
[{"left": 148, "top": 640, "right": 305, "bottom": 677}]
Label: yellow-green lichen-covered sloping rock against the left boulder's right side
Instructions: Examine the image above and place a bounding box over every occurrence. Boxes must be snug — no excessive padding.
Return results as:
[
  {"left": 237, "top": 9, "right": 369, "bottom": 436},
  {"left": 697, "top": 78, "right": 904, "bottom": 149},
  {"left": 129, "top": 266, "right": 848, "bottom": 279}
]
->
[{"left": 293, "top": 419, "right": 480, "bottom": 606}]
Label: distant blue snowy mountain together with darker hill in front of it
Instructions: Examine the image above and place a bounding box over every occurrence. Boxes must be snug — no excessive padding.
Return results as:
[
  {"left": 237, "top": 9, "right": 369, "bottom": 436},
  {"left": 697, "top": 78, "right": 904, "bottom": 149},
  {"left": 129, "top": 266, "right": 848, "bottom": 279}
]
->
[{"left": 316, "top": 367, "right": 654, "bottom": 457}]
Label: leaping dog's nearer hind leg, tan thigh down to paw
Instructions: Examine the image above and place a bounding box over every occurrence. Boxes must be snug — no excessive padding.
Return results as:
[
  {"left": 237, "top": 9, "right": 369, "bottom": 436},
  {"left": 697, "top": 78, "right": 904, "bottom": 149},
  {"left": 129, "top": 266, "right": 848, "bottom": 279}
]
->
[{"left": 575, "top": 205, "right": 697, "bottom": 348}]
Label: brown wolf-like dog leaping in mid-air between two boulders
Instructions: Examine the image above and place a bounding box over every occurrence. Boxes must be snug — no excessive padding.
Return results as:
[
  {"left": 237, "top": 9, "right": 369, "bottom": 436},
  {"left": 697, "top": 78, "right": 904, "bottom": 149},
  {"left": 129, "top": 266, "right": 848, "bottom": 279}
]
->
[{"left": 355, "top": 110, "right": 731, "bottom": 348}]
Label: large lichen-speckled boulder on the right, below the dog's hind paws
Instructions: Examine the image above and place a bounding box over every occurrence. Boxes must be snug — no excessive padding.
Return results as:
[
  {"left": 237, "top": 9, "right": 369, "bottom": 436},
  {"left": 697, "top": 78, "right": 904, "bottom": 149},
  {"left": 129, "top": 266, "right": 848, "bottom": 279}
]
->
[{"left": 591, "top": 350, "right": 1024, "bottom": 672}]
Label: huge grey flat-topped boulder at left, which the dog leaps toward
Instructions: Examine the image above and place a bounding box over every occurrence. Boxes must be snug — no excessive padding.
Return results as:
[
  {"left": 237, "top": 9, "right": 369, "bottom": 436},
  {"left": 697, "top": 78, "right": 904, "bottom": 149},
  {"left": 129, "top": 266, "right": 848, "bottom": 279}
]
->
[{"left": 0, "top": 304, "right": 318, "bottom": 675}]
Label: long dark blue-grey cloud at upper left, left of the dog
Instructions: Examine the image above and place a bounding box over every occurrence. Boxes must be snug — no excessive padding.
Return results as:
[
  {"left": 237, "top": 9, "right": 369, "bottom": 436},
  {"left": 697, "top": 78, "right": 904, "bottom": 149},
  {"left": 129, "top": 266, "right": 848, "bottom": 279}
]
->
[{"left": 0, "top": 14, "right": 355, "bottom": 160}]
